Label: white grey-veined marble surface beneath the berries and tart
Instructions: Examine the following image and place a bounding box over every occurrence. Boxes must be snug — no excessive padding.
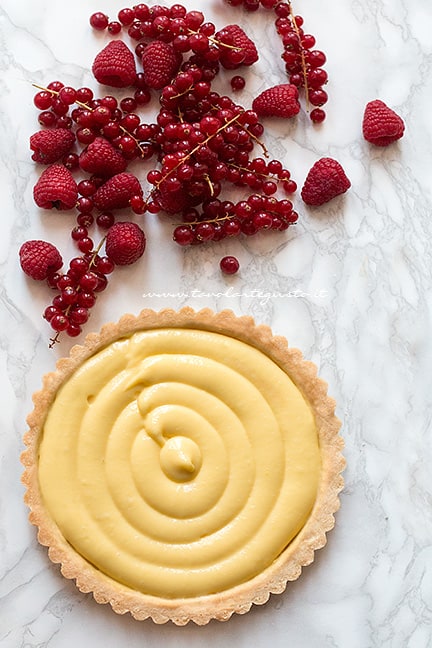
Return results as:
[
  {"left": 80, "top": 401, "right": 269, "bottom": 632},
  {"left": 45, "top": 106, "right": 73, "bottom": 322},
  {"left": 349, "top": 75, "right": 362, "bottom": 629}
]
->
[{"left": 0, "top": 0, "right": 432, "bottom": 648}]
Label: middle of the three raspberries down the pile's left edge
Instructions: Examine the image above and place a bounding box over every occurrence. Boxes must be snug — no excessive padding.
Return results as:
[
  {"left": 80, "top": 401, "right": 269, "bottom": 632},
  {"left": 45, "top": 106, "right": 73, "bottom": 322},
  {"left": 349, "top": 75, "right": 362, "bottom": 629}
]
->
[{"left": 33, "top": 164, "right": 78, "bottom": 210}]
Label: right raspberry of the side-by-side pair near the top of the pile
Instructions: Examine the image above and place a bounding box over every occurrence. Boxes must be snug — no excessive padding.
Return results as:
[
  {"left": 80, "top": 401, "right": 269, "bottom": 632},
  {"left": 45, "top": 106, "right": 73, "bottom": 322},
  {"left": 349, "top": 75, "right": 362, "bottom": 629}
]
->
[{"left": 142, "top": 41, "right": 182, "bottom": 90}]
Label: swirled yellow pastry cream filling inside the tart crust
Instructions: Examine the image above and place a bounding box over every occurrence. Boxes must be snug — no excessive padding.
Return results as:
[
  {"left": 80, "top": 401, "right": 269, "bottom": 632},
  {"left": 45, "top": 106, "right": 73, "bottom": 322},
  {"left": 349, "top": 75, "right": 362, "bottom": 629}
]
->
[{"left": 38, "top": 328, "right": 321, "bottom": 599}]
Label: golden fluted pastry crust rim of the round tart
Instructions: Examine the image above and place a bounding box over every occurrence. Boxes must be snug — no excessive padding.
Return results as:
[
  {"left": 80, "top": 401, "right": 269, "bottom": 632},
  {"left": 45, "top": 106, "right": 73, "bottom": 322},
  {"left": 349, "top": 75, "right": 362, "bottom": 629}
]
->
[{"left": 21, "top": 307, "right": 345, "bottom": 625}]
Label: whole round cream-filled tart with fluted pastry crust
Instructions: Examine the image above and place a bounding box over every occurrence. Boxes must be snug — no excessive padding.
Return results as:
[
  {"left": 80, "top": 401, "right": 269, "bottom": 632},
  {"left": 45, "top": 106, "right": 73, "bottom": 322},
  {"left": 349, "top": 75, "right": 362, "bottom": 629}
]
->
[{"left": 22, "top": 308, "right": 345, "bottom": 625}]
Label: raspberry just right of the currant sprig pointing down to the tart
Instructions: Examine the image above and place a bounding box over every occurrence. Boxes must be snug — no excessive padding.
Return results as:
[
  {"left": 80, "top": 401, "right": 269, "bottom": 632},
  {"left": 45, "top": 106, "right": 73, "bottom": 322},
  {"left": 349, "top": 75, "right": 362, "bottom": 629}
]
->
[{"left": 105, "top": 221, "right": 146, "bottom": 265}]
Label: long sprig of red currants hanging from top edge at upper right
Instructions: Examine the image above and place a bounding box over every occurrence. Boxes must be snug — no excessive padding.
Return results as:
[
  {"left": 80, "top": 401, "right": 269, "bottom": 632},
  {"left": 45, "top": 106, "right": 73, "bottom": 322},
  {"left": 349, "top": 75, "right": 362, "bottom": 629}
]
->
[{"left": 226, "top": 0, "right": 328, "bottom": 124}]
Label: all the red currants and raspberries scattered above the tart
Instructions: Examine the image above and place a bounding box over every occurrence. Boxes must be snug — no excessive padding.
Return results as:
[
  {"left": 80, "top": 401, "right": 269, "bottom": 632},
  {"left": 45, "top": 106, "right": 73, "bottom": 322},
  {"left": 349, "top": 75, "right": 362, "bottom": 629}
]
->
[{"left": 20, "top": 0, "right": 403, "bottom": 344}]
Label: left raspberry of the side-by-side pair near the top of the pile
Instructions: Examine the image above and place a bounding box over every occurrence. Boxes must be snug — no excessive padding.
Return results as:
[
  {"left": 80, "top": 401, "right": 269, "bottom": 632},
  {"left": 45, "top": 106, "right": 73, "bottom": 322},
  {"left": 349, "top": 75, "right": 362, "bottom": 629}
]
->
[{"left": 92, "top": 40, "right": 137, "bottom": 88}]
